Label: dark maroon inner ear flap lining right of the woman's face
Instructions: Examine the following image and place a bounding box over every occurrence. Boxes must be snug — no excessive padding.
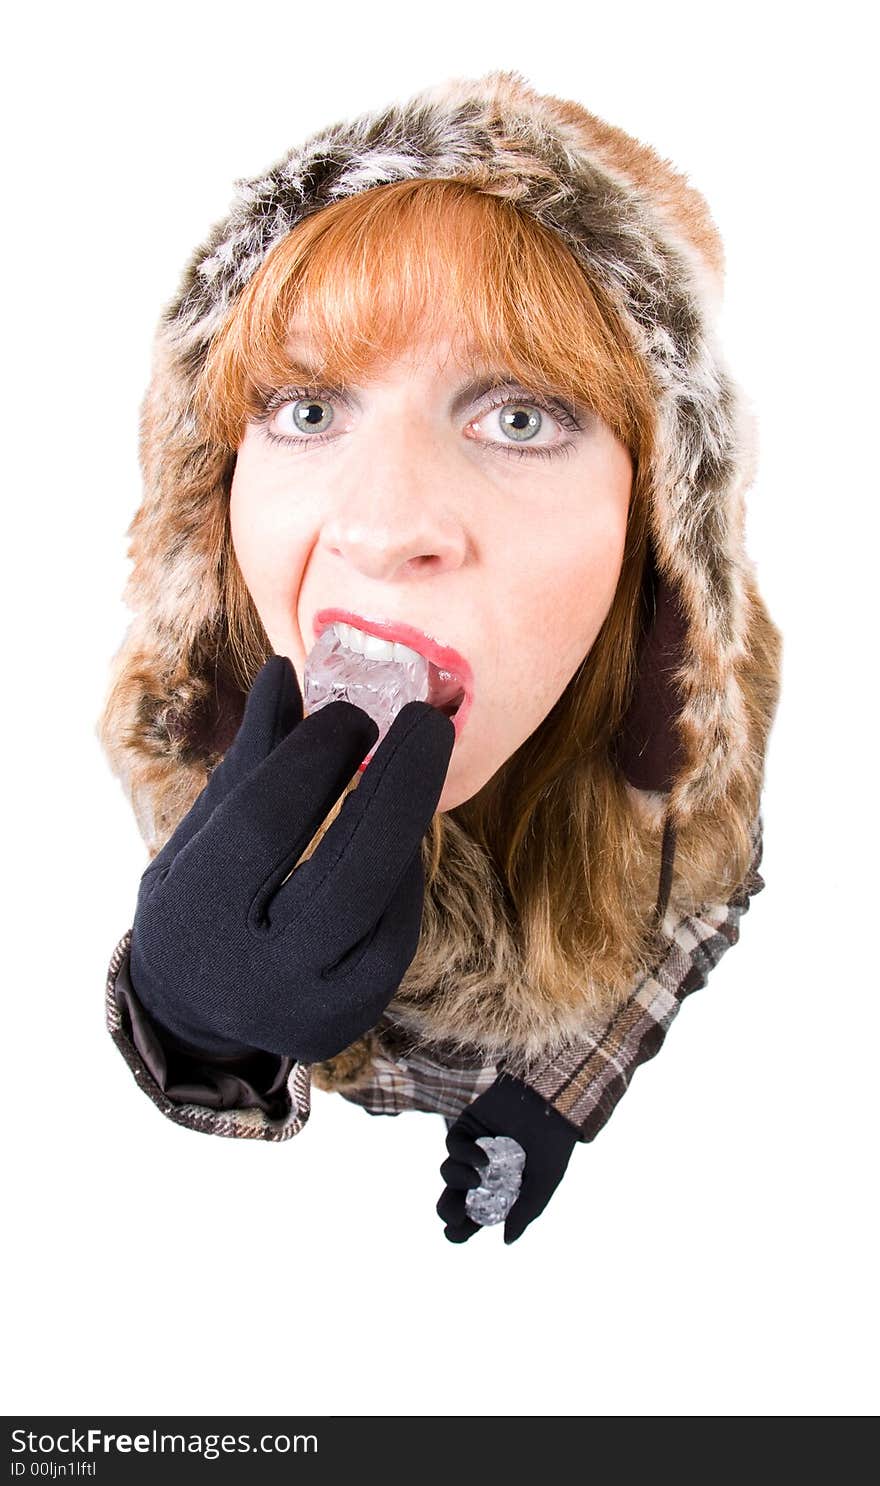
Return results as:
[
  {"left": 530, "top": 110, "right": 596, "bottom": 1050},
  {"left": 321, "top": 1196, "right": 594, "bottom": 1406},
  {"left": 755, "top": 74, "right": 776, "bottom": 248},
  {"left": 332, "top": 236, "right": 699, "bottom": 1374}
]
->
[{"left": 615, "top": 541, "right": 687, "bottom": 792}]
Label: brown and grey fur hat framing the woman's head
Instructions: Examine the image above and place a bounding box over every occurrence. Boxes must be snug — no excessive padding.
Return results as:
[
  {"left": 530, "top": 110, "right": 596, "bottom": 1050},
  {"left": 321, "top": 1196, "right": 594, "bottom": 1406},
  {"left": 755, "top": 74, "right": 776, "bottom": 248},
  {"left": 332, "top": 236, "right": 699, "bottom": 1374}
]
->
[{"left": 103, "top": 71, "right": 776, "bottom": 909}]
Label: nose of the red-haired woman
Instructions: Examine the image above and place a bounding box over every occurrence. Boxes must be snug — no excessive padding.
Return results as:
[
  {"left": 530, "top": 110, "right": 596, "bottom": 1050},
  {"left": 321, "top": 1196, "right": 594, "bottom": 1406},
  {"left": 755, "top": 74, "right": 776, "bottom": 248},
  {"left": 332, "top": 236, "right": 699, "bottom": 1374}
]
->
[{"left": 320, "top": 422, "right": 467, "bottom": 581}]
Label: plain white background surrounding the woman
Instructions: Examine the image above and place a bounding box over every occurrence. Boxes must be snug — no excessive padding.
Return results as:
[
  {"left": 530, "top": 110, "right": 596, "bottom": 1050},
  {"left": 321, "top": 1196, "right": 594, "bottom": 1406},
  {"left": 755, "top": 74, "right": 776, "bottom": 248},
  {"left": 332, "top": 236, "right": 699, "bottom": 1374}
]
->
[{"left": 0, "top": 0, "right": 877, "bottom": 1415}]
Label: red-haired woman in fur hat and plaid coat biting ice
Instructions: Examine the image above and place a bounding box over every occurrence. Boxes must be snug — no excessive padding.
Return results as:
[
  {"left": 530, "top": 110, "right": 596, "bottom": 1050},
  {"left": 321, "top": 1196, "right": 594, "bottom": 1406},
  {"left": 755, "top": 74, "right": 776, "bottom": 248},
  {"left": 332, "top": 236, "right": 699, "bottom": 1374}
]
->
[{"left": 100, "top": 73, "right": 780, "bottom": 1242}]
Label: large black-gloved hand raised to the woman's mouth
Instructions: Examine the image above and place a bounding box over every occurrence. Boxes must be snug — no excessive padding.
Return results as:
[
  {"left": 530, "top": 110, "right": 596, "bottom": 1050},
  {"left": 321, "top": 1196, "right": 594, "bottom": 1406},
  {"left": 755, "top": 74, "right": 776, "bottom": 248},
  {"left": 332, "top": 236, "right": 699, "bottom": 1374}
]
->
[{"left": 129, "top": 655, "right": 455, "bottom": 1062}]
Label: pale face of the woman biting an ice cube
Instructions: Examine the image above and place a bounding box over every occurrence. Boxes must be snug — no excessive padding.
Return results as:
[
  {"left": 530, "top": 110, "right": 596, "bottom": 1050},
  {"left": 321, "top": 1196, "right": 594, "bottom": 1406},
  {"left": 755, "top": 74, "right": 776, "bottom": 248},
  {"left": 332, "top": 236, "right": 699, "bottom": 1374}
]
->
[{"left": 230, "top": 334, "right": 632, "bottom": 810}]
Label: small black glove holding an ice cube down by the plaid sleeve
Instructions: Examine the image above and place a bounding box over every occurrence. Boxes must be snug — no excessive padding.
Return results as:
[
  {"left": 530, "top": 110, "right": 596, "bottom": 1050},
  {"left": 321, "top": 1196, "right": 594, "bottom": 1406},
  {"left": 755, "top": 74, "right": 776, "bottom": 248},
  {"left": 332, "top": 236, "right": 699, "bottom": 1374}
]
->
[{"left": 437, "top": 1073, "right": 580, "bottom": 1244}]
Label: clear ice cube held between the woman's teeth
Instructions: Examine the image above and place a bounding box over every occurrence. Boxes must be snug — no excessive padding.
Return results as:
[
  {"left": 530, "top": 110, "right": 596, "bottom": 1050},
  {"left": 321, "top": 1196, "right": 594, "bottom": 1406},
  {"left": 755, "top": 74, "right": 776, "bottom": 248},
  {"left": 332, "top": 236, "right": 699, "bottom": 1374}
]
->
[{"left": 303, "top": 624, "right": 430, "bottom": 759}]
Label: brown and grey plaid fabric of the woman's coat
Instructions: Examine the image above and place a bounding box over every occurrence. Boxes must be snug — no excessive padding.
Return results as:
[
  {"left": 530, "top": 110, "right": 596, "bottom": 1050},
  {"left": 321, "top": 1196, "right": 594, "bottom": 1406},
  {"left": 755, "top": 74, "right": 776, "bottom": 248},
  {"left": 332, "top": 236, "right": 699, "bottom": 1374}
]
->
[{"left": 106, "top": 817, "right": 766, "bottom": 1141}]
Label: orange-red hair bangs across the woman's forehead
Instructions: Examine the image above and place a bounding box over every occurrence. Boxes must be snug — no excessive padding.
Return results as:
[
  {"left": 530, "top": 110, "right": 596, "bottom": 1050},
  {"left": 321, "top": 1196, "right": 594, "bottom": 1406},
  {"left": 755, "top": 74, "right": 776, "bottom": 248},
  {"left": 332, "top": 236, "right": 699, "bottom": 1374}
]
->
[{"left": 196, "top": 178, "right": 653, "bottom": 459}]
